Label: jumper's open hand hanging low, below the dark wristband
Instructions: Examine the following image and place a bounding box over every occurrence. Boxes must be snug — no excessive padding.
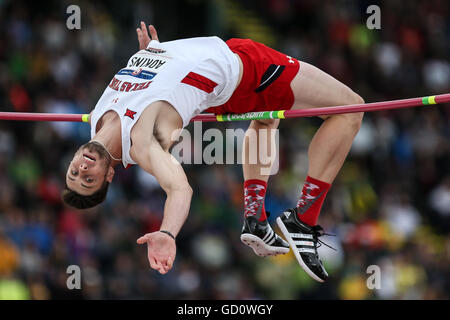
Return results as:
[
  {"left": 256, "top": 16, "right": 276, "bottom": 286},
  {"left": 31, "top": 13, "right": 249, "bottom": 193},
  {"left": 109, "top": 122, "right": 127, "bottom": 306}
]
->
[{"left": 137, "top": 231, "right": 177, "bottom": 274}]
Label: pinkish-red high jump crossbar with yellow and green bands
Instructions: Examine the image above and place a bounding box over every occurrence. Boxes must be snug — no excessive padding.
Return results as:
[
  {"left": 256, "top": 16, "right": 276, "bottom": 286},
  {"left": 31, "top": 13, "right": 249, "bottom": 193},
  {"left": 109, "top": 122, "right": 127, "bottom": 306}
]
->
[{"left": 0, "top": 93, "right": 450, "bottom": 122}]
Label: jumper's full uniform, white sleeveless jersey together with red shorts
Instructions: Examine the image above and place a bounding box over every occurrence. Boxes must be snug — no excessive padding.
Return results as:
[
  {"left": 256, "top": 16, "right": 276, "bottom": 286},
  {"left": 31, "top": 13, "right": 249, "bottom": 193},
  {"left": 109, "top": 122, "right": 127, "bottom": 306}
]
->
[{"left": 91, "top": 37, "right": 299, "bottom": 167}]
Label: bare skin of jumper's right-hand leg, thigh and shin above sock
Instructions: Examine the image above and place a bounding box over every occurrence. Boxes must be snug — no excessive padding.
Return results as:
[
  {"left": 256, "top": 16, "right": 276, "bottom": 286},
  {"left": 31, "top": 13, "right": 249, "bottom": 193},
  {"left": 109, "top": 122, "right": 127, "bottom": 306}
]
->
[{"left": 291, "top": 62, "right": 364, "bottom": 184}]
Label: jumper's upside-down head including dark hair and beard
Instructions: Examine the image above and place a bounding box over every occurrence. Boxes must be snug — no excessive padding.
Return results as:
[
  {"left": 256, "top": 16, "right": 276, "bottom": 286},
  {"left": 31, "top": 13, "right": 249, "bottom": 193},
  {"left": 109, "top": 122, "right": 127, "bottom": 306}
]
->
[{"left": 62, "top": 141, "right": 114, "bottom": 209}]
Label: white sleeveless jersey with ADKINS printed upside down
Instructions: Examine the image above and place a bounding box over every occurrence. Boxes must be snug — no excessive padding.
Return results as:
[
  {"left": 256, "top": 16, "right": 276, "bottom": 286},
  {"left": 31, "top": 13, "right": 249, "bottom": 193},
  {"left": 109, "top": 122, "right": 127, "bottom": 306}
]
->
[{"left": 91, "top": 37, "right": 239, "bottom": 167}]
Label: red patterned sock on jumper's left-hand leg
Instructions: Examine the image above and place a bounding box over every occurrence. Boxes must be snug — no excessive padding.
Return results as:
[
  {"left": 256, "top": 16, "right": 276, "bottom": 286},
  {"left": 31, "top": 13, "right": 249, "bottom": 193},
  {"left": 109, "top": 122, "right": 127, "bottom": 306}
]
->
[{"left": 244, "top": 179, "right": 267, "bottom": 221}]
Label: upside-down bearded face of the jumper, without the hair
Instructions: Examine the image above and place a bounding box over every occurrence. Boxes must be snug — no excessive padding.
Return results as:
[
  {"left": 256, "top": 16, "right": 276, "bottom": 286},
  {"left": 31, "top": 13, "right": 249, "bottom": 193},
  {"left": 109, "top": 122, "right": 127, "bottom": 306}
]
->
[{"left": 66, "top": 142, "right": 114, "bottom": 196}]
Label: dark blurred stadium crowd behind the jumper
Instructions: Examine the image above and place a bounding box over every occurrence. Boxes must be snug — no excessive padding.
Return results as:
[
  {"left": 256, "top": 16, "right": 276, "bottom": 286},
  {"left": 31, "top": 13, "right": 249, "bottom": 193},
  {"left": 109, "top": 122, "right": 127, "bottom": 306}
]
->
[{"left": 0, "top": 0, "right": 450, "bottom": 299}]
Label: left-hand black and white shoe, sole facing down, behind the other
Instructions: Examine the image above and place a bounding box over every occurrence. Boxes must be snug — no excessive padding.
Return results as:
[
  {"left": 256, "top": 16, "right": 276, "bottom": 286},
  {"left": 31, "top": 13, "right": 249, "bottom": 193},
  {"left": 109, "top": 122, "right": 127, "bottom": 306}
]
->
[{"left": 241, "top": 216, "right": 289, "bottom": 257}]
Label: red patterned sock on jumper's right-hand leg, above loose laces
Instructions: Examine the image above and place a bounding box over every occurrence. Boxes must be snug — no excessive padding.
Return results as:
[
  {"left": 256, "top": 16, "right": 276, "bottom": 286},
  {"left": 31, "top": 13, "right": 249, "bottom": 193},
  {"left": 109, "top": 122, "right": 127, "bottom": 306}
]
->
[{"left": 297, "top": 176, "right": 331, "bottom": 226}]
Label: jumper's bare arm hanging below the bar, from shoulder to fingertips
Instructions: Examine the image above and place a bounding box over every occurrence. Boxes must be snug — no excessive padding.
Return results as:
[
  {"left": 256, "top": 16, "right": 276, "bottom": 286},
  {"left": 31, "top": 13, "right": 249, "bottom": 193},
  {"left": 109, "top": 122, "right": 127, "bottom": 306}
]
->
[{"left": 136, "top": 137, "right": 192, "bottom": 274}]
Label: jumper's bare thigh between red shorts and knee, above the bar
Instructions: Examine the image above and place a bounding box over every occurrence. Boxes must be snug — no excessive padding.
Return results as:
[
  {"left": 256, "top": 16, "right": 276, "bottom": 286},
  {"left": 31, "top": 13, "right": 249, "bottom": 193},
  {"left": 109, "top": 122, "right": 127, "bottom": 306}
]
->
[{"left": 291, "top": 62, "right": 362, "bottom": 109}]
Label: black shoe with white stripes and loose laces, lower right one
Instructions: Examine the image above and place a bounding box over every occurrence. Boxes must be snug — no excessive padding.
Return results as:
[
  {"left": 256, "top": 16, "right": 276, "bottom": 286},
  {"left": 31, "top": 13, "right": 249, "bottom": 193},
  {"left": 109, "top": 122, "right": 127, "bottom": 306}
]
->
[{"left": 277, "top": 209, "right": 333, "bottom": 282}]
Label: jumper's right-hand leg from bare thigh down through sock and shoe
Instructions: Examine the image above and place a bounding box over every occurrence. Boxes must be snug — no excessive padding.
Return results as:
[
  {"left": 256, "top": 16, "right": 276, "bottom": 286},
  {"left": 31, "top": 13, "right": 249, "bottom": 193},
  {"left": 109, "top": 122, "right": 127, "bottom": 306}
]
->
[{"left": 277, "top": 62, "right": 364, "bottom": 282}]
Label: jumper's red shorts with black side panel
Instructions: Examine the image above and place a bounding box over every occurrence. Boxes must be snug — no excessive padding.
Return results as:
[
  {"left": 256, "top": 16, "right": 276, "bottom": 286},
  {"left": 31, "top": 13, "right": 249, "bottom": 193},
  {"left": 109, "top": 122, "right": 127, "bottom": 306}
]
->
[{"left": 206, "top": 39, "right": 300, "bottom": 114}]
